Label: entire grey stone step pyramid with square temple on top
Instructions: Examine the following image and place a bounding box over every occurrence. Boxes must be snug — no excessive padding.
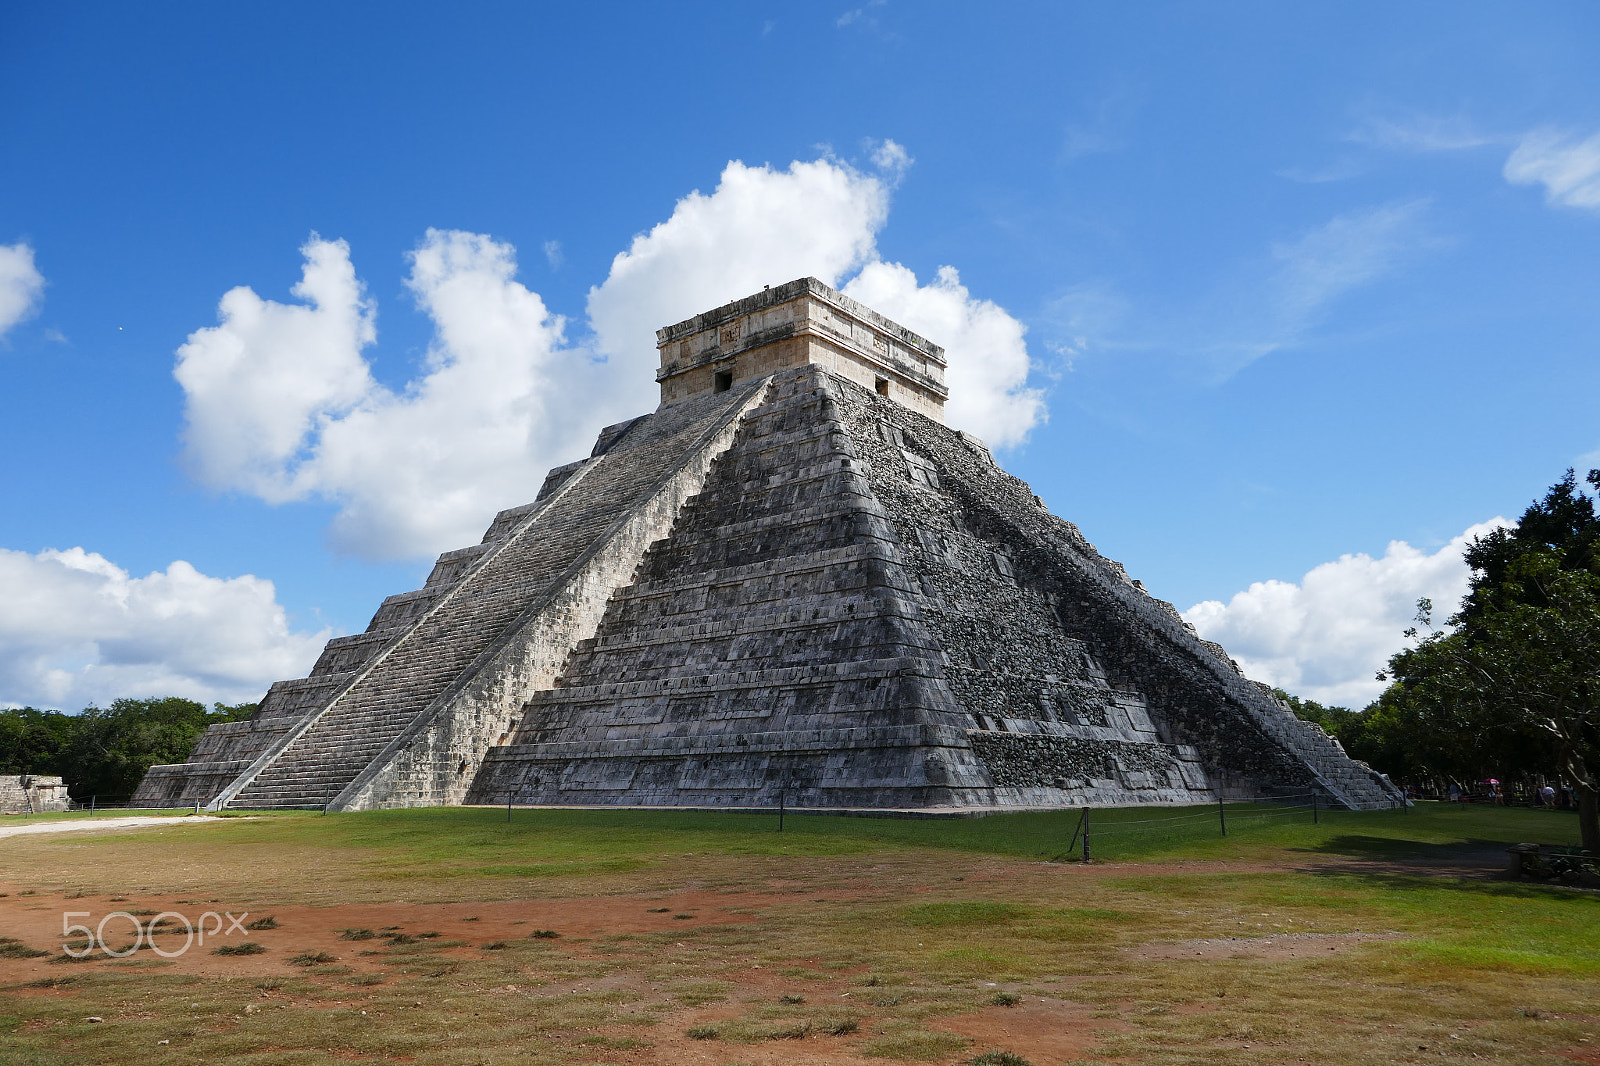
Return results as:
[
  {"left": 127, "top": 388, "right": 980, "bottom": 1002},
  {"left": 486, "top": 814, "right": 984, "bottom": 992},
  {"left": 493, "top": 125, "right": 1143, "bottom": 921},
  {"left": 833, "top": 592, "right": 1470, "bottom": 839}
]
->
[{"left": 136, "top": 279, "right": 1400, "bottom": 810}]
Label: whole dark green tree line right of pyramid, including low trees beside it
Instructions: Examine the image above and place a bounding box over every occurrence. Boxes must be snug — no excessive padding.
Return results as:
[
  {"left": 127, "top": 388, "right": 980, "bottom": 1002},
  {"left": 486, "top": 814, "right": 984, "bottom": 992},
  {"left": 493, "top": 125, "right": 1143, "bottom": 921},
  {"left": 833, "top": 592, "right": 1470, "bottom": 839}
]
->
[{"left": 1278, "top": 471, "right": 1600, "bottom": 850}]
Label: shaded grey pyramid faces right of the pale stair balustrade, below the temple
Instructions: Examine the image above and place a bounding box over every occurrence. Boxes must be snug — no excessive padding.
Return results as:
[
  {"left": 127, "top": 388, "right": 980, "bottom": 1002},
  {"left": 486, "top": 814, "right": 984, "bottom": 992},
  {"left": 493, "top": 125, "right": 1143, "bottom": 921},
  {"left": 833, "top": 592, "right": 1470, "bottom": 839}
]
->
[{"left": 469, "top": 367, "right": 1389, "bottom": 807}]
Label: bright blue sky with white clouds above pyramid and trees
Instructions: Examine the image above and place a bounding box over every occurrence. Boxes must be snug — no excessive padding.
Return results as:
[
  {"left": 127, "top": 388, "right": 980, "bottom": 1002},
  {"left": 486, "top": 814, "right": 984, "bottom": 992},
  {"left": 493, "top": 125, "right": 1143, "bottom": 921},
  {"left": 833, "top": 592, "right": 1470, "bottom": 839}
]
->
[{"left": 0, "top": 0, "right": 1600, "bottom": 707}]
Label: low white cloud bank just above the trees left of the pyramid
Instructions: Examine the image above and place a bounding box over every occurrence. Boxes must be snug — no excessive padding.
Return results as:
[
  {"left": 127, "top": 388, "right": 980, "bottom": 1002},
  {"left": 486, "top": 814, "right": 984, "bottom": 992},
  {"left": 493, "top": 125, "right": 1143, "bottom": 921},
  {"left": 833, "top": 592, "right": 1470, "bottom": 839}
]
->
[{"left": 0, "top": 547, "right": 331, "bottom": 711}]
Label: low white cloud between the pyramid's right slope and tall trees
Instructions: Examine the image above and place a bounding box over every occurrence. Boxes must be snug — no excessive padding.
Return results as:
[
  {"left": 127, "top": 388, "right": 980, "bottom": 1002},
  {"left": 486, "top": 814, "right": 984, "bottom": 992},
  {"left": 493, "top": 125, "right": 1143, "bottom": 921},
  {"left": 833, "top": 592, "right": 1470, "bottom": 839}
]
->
[{"left": 1184, "top": 519, "right": 1506, "bottom": 707}]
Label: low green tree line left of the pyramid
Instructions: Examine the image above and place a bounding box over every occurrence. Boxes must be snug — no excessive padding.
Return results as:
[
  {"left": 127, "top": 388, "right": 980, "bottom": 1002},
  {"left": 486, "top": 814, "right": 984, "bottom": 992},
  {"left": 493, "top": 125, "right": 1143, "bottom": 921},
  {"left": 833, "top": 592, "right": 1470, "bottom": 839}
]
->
[{"left": 0, "top": 696, "right": 256, "bottom": 802}]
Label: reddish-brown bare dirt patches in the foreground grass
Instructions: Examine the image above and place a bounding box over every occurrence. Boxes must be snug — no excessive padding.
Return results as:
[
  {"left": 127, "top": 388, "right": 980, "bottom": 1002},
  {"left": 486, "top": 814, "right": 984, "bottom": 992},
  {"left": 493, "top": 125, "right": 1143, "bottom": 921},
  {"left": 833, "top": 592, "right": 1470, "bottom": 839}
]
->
[{"left": 0, "top": 861, "right": 1427, "bottom": 1066}]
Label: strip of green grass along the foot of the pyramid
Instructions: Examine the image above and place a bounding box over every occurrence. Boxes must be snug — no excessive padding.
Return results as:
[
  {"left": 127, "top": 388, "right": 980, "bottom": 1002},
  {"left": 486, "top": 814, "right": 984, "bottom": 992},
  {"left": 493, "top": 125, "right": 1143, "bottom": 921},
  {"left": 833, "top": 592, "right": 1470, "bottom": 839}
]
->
[{"left": 124, "top": 804, "right": 1578, "bottom": 877}]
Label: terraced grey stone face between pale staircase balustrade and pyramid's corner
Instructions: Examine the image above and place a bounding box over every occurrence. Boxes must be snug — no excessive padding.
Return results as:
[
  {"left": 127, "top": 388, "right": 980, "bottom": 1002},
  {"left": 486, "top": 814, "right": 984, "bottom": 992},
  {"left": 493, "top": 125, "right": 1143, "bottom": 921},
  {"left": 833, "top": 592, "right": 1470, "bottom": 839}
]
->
[{"left": 469, "top": 375, "right": 985, "bottom": 805}]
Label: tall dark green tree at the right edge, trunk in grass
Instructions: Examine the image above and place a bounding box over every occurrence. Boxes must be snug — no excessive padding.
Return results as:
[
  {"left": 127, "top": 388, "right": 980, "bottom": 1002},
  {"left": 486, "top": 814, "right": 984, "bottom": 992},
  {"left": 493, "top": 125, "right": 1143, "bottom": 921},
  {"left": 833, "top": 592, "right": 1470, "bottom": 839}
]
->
[{"left": 1379, "top": 471, "right": 1600, "bottom": 850}]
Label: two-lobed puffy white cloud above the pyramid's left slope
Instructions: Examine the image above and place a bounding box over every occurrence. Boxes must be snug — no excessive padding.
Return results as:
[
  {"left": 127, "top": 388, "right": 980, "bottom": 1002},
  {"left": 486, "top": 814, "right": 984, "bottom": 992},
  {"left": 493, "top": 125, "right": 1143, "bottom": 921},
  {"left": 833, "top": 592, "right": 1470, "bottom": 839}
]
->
[{"left": 176, "top": 230, "right": 622, "bottom": 559}]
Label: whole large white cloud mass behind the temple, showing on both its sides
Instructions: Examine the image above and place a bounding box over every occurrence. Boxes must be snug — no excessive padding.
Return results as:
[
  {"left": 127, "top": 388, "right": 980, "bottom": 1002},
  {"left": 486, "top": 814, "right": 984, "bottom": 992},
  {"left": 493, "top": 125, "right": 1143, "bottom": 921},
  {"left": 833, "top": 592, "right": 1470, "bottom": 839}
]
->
[{"left": 174, "top": 151, "right": 1043, "bottom": 559}]
